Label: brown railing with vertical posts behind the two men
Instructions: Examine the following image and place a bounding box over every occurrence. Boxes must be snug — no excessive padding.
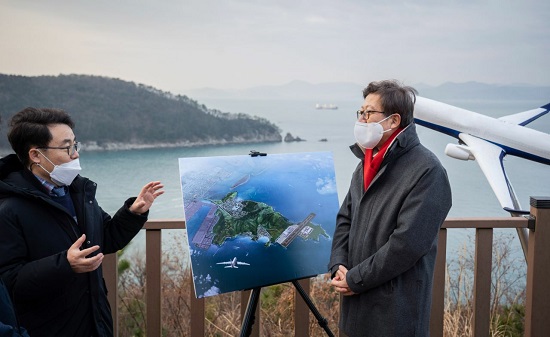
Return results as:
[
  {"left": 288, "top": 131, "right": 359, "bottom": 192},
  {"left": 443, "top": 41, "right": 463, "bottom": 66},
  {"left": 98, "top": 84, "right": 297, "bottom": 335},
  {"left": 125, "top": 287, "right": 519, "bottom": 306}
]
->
[{"left": 103, "top": 197, "right": 550, "bottom": 337}]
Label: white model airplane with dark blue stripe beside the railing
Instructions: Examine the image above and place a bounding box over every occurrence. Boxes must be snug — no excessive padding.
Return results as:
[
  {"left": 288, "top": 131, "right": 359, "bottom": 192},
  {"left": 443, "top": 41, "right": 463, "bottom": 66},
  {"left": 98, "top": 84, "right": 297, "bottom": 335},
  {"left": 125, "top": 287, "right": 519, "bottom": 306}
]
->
[{"left": 414, "top": 97, "right": 550, "bottom": 254}]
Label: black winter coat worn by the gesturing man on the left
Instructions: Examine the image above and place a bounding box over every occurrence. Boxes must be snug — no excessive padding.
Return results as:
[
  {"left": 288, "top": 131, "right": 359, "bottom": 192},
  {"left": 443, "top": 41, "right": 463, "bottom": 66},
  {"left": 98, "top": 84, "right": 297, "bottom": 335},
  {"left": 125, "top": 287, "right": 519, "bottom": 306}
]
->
[{"left": 0, "top": 155, "right": 147, "bottom": 337}]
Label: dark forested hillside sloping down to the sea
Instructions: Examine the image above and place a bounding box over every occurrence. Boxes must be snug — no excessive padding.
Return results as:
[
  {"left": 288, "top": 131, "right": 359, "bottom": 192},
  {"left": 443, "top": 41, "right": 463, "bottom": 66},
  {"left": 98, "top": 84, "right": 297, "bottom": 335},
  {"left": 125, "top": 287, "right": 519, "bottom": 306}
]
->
[{"left": 0, "top": 74, "right": 282, "bottom": 149}]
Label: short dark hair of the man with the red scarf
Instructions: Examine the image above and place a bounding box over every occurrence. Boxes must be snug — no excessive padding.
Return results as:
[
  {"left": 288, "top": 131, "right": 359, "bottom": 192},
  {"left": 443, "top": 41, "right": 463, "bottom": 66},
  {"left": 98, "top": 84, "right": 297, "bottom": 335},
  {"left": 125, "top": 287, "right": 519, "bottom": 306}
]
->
[{"left": 363, "top": 80, "right": 418, "bottom": 127}]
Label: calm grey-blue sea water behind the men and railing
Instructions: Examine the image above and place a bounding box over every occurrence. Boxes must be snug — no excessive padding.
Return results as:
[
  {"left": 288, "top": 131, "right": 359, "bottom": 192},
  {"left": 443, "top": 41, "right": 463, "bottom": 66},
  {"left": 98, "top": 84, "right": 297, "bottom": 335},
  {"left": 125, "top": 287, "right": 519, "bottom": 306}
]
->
[{"left": 75, "top": 97, "right": 550, "bottom": 266}]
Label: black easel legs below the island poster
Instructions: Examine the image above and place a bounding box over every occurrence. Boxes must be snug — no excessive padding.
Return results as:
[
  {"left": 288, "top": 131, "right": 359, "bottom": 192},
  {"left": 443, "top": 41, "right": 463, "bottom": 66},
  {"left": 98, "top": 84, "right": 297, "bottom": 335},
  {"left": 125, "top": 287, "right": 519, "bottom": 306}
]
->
[{"left": 241, "top": 280, "right": 334, "bottom": 337}]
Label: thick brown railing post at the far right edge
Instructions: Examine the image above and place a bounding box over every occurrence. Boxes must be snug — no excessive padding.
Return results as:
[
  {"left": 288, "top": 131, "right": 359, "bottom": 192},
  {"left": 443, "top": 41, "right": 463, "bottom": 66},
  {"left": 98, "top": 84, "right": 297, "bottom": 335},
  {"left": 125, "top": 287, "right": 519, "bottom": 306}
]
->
[{"left": 525, "top": 197, "right": 550, "bottom": 337}]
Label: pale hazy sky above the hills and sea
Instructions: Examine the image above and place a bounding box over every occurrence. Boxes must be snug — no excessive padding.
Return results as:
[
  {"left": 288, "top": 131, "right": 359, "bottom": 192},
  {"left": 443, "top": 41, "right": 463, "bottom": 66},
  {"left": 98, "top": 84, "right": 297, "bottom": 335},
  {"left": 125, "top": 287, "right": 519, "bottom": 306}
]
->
[{"left": 0, "top": 0, "right": 550, "bottom": 93}]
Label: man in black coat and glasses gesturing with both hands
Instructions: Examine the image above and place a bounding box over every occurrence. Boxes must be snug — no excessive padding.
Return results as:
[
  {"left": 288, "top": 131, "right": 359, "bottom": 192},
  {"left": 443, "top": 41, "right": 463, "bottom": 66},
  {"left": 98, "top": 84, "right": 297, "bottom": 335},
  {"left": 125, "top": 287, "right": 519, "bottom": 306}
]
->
[{"left": 0, "top": 108, "right": 164, "bottom": 337}]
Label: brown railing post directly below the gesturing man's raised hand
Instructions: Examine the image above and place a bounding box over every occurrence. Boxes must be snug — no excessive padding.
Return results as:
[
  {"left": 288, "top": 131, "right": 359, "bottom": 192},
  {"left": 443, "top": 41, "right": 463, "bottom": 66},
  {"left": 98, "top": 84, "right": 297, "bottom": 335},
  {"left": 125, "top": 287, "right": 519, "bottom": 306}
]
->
[{"left": 145, "top": 229, "right": 162, "bottom": 337}]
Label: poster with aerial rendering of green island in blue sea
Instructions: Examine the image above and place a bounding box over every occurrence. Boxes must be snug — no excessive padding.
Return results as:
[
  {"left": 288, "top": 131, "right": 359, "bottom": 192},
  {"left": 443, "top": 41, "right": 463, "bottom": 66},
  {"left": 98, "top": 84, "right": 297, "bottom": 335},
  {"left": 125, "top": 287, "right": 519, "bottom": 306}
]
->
[{"left": 179, "top": 152, "right": 339, "bottom": 298}]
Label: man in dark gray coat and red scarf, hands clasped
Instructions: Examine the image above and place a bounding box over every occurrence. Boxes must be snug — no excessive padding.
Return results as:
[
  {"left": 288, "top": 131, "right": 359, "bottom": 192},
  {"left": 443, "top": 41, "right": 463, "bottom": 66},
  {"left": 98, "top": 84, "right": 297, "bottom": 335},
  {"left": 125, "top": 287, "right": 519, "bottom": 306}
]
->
[{"left": 328, "top": 81, "right": 451, "bottom": 337}]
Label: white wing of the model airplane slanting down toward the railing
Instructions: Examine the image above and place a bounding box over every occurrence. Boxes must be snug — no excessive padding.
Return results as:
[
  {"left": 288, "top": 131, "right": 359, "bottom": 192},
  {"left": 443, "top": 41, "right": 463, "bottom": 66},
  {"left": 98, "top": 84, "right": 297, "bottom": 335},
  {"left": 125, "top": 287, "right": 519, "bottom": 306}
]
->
[{"left": 458, "top": 133, "right": 521, "bottom": 212}]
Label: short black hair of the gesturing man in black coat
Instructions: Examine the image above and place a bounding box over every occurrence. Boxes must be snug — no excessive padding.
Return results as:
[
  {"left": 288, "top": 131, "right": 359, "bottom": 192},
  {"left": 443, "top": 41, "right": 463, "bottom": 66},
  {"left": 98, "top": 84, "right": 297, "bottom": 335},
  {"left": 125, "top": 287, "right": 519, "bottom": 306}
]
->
[{"left": 8, "top": 107, "right": 74, "bottom": 167}]
